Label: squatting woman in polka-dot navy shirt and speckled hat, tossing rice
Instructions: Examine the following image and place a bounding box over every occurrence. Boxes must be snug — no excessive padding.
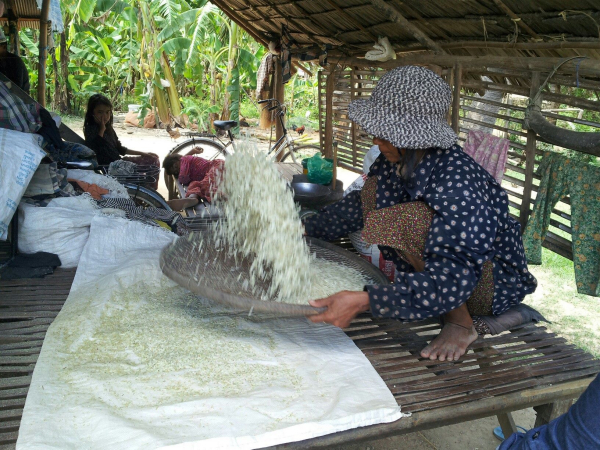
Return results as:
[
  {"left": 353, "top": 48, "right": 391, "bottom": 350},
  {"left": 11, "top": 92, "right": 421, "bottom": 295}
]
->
[{"left": 304, "top": 66, "right": 537, "bottom": 361}]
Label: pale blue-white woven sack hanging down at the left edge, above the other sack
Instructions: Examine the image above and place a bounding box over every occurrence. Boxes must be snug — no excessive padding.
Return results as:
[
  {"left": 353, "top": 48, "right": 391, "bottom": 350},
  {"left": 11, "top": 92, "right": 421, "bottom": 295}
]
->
[{"left": 0, "top": 128, "right": 46, "bottom": 240}]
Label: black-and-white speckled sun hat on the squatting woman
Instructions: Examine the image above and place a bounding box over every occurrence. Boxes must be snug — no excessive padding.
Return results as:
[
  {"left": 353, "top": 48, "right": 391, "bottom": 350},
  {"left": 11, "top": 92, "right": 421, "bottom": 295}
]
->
[{"left": 348, "top": 66, "right": 457, "bottom": 149}]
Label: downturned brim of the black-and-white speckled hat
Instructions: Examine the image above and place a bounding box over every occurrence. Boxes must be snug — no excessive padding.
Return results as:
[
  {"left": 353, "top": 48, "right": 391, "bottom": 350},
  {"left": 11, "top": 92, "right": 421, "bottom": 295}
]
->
[{"left": 348, "top": 99, "right": 458, "bottom": 149}]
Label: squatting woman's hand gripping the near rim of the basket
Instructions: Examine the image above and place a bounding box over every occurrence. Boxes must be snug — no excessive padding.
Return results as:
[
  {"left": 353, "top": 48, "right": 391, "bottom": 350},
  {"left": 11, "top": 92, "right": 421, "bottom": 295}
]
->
[{"left": 308, "top": 291, "right": 370, "bottom": 328}]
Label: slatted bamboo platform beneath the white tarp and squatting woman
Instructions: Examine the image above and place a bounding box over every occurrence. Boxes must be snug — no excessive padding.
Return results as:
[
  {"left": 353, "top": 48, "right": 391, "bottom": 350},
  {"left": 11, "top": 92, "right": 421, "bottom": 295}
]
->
[{"left": 0, "top": 270, "right": 600, "bottom": 450}]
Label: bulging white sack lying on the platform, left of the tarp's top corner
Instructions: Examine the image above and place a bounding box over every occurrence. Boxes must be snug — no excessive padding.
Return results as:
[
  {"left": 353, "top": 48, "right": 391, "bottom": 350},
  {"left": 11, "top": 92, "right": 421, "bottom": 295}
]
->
[{"left": 19, "top": 204, "right": 96, "bottom": 268}]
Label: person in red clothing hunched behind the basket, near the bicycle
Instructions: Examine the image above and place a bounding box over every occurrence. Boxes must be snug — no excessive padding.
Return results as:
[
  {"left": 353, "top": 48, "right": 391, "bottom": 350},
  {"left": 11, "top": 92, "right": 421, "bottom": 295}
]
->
[{"left": 163, "top": 147, "right": 225, "bottom": 211}]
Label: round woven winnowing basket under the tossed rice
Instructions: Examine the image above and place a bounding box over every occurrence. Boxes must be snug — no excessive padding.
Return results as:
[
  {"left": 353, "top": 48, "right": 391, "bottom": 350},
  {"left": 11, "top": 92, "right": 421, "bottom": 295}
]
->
[{"left": 160, "top": 232, "right": 389, "bottom": 316}]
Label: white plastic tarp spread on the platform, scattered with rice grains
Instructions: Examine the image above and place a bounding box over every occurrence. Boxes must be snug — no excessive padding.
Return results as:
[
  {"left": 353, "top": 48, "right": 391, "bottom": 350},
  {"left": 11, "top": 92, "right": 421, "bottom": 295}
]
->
[{"left": 17, "top": 216, "right": 402, "bottom": 450}]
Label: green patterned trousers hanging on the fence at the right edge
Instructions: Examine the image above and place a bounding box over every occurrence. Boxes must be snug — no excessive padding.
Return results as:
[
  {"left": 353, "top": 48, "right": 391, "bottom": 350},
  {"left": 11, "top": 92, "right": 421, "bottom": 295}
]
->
[{"left": 523, "top": 152, "right": 600, "bottom": 297}]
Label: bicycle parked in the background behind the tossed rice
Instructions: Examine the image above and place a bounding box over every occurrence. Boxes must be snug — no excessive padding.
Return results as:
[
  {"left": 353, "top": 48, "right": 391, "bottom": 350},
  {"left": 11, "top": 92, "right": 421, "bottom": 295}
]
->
[{"left": 164, "top": 98, "right": 321, "bottom": 200}]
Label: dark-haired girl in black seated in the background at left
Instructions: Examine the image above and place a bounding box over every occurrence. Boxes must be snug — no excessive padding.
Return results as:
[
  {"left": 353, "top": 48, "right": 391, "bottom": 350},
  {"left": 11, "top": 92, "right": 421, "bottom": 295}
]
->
[{"left": 83, "top": 94, "right": 160, "bottom": 177}]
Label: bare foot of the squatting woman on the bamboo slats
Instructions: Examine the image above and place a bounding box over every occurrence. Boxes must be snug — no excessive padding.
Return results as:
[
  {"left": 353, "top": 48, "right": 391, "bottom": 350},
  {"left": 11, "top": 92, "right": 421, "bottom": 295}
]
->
[{"left": 421, "top": 322, "right": 477, "bottom": 361}]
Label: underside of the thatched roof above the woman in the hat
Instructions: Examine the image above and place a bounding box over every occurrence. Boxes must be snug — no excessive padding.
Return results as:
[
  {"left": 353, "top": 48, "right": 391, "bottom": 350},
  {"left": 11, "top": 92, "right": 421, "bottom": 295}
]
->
[{"left": 213, "top": 0, "right": 600, "bottom": 59}]
